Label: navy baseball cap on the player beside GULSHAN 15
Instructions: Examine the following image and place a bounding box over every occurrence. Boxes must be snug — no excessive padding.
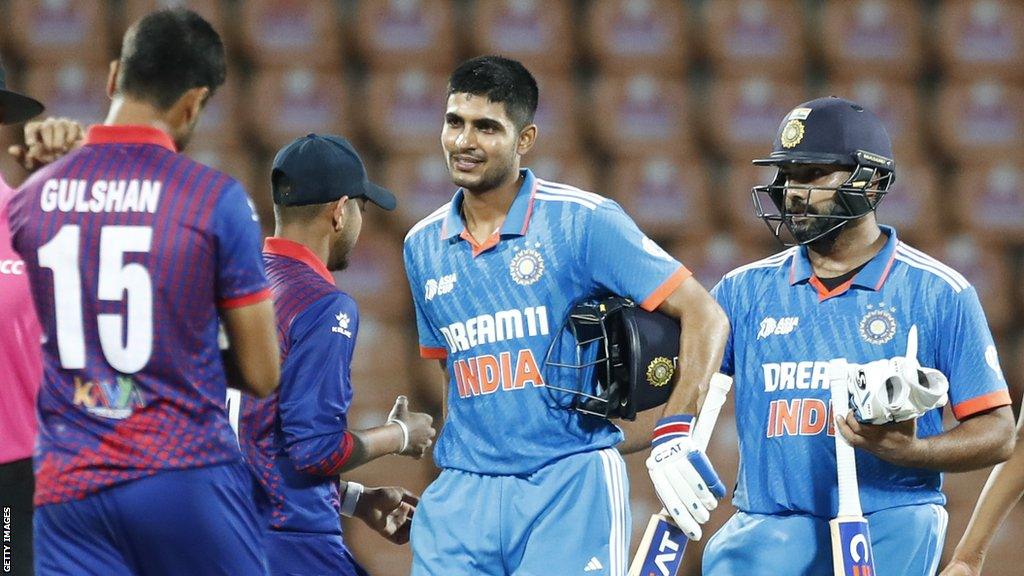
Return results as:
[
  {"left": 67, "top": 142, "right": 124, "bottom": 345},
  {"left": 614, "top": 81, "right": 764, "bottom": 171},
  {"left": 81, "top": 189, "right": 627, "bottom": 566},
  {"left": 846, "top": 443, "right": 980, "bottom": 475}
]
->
[{"left": 270, "top": 134, "right": 396, "bottom": 210}]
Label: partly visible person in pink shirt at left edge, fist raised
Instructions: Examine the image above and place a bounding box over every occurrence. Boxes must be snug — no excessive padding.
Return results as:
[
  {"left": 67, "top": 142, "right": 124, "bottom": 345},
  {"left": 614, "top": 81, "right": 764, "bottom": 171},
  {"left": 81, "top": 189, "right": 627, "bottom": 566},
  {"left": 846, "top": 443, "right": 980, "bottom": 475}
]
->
[{"left": 0, "top": 61, "right": 82, "bottom": 576}]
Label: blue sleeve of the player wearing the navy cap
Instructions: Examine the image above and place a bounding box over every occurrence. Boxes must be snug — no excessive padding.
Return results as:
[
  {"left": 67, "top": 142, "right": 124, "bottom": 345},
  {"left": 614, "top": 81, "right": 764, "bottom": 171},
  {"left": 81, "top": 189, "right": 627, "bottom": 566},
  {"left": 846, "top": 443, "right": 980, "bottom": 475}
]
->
[{"left": 278, "top": 293, "right": 359, "bottom": 476}]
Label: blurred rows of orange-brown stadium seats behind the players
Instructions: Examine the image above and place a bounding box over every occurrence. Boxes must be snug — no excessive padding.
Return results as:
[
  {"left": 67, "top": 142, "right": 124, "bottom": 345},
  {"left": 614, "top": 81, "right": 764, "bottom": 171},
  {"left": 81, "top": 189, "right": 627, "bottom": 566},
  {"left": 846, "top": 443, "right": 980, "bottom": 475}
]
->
[{"left": 0, "top": 0, "right": 1024, "bottom": 576}]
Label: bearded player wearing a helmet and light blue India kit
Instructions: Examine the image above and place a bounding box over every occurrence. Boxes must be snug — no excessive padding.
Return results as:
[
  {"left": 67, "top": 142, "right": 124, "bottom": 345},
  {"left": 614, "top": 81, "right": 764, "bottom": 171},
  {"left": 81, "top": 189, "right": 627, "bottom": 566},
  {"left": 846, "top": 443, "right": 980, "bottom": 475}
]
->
[{"left": 703, "top": 97, "right": 1013, "bottom": 575}]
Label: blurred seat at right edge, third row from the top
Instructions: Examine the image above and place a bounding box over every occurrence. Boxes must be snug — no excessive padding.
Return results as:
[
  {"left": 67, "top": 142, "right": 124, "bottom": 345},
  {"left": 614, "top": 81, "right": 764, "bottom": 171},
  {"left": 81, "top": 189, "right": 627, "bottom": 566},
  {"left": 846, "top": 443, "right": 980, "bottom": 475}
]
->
[{"left": 949, "top": 161, "right": 1024, "bottom": 243}]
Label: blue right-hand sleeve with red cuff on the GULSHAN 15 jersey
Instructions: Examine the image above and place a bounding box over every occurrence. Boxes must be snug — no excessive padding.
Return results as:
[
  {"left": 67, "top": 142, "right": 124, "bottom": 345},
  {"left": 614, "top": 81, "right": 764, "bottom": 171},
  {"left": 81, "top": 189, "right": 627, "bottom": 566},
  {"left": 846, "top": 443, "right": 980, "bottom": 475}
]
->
[{"left": 212, "top": 182, "right": 270, "bottom": 308}]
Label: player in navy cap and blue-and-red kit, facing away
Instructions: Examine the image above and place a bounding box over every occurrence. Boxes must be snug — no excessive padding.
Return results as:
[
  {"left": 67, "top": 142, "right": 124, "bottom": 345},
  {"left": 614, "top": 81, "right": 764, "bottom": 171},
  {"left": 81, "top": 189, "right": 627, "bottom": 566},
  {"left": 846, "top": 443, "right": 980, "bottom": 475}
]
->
[{"left": 240, "top": 134, "right": 434, "bottom": 576}]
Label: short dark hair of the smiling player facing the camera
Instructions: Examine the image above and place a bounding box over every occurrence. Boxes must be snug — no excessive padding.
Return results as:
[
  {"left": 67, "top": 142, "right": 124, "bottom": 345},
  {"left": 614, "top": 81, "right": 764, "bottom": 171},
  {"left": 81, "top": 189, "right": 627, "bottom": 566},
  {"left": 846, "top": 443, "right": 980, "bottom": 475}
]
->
[{"left": 447, "top": 56, "right": 540, "bottom": 128}]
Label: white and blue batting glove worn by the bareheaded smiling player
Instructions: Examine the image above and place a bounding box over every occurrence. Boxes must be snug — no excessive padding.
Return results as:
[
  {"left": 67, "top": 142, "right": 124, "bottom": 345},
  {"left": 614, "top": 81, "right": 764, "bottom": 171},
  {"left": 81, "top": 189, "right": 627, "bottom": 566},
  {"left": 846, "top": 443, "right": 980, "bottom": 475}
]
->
[{"left": 647, "top": 414, "right": 725, "bottom": 540}]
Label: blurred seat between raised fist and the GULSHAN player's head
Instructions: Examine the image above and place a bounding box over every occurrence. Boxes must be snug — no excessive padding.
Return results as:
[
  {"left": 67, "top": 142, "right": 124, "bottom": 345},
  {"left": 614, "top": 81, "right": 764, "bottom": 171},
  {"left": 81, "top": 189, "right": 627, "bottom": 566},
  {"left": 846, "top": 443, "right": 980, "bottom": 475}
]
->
[{"left": 20, "top": 60, "right": 111, "bottom": 126}]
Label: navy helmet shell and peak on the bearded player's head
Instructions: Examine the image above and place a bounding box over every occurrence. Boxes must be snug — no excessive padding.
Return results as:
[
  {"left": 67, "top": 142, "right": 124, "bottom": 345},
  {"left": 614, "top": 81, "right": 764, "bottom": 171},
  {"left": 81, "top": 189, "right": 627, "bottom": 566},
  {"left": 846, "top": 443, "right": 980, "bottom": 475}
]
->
[{"left": 754, "top": 96, "right": 895, "bottom": 171}]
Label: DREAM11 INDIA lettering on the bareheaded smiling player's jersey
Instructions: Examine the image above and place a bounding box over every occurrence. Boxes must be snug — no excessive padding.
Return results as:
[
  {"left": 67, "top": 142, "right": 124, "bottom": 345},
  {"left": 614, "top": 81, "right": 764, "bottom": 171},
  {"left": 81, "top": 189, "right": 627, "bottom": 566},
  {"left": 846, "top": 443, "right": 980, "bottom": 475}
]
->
[{"left": 440, "top": 306, "right": 550, "bottom": 398}]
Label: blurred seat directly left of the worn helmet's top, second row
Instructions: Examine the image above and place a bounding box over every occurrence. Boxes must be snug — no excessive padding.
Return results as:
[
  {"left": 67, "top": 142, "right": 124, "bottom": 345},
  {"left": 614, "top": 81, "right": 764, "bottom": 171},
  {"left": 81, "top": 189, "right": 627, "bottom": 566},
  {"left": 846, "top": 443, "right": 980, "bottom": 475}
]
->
[{"left": 695, "top": 77, "right": 809, "bottom": 161}]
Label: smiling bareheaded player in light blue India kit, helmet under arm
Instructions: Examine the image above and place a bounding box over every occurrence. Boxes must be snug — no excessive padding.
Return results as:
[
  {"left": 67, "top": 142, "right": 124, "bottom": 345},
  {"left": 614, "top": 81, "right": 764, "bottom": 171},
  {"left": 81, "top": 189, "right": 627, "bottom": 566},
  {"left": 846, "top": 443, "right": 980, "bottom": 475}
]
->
[{"left": 404, "top": 56, "right": 728, "bottom": 576}]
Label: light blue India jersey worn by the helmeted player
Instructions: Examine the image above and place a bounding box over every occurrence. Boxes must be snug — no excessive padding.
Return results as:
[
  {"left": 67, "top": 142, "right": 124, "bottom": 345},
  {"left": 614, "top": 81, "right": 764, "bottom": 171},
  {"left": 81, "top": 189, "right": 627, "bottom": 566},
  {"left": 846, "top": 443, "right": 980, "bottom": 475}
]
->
[{"left": 712, "top": 227, "right": 1010, "bottom": 518}]
